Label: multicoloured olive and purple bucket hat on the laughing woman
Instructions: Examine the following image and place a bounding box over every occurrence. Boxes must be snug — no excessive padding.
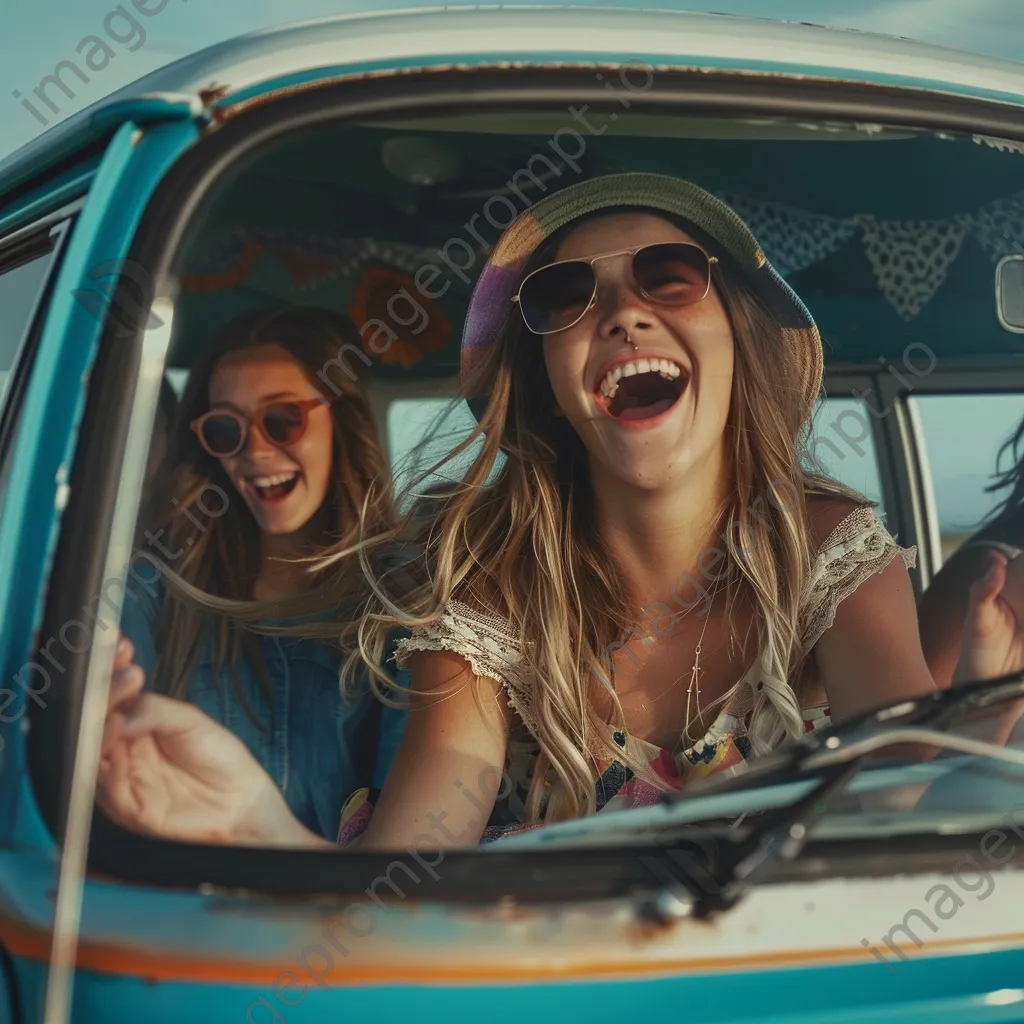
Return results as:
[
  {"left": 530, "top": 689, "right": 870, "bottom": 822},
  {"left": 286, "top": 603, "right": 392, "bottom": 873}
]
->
[{"left": 461, "top": 172, "right": 821, "bottom": 387}]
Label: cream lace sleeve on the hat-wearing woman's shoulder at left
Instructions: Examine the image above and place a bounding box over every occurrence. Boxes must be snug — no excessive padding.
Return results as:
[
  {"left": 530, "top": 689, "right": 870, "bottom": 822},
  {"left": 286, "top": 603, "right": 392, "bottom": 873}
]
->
[{"left": 394, "top": 601, "right": 537, "bottom": 731}]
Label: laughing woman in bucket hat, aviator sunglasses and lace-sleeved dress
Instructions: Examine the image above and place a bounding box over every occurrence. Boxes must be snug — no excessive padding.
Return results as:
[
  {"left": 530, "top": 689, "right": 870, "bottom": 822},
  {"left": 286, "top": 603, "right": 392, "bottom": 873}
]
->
[{"left": 99, "top": 174, "right": 1016, "bottom": 848}]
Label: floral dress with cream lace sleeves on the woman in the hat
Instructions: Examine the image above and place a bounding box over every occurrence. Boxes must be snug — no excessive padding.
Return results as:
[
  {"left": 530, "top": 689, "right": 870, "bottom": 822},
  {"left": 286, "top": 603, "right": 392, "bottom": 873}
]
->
[{"left": 338, "top": 506, "right": 915, "bottom": 845}]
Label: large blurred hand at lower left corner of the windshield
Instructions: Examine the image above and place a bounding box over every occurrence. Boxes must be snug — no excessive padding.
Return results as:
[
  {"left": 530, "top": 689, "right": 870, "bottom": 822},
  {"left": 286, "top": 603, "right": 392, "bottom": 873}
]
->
[{"left": 96, "top": 638, "right": 325, "bottom": 846}]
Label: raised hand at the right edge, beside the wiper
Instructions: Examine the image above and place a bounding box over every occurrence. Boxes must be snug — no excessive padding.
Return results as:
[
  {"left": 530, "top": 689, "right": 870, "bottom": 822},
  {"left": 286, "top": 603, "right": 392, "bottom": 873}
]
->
[{"left": 953, "top": 550, "right": 1024, "bottom": 686}]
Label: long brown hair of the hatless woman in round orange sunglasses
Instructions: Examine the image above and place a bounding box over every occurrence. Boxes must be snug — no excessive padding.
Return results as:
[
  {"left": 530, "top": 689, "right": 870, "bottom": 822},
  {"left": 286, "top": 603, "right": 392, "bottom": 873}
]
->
[{"left": 139, "top": 307, "right": 394, "bottom": 696}]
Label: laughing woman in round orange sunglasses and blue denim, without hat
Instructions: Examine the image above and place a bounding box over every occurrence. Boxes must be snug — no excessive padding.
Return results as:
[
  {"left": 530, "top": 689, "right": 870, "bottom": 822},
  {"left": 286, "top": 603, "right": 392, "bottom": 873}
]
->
[{"left": 122, "top": 308, "right": 403, "bottom": 839}]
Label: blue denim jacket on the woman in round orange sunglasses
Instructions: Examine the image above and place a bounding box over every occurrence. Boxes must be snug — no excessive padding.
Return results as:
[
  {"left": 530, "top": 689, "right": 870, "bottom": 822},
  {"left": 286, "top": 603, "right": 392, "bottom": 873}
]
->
[{"left": 121, "top": 583, "right": 409, "bottom": 840}]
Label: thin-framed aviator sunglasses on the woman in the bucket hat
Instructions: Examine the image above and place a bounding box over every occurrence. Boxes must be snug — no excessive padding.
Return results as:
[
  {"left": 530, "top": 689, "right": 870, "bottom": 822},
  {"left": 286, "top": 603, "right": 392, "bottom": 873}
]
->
[{"left": 512, "top": 242, "right": 718, "bottom": 335}]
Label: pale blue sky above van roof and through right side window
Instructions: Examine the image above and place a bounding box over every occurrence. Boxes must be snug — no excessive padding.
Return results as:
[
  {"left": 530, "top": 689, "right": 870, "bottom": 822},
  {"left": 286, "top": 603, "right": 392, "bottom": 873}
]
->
[{"left": 0, "top": 0, "right": 1024, "bottom": 528}]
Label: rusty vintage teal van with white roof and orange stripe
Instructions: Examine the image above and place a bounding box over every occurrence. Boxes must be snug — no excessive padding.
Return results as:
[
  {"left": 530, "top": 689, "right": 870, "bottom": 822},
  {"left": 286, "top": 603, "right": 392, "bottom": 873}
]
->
[{"left": 0, "top": 6, "right": 1024, "bottom": 1024}]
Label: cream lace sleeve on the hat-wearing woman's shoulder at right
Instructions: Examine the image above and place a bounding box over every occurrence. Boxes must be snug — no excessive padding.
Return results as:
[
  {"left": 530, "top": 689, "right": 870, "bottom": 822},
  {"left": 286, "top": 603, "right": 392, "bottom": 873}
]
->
[{"left": 801, "top": 506, "right": 918, "bottom": 650}]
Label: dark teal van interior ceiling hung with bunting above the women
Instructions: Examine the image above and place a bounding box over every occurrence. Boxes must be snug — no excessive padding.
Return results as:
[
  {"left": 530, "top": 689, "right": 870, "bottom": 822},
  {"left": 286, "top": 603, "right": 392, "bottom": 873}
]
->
[{"left": 163, "top": 111, "right": 1024, "bottom": 477}]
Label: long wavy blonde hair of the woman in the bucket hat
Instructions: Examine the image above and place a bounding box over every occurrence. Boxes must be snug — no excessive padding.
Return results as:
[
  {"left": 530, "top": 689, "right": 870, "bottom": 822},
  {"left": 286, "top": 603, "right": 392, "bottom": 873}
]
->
[{"left": 346, "top": 210, "right": 849, "bottom": 821}]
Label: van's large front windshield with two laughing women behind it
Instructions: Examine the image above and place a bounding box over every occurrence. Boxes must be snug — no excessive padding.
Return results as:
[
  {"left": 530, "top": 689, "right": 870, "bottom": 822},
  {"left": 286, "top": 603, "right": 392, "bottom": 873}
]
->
[{"left": 100, "top": 101, "right": 1024, "bottom": 864}]
